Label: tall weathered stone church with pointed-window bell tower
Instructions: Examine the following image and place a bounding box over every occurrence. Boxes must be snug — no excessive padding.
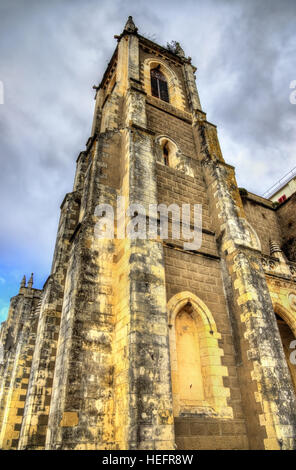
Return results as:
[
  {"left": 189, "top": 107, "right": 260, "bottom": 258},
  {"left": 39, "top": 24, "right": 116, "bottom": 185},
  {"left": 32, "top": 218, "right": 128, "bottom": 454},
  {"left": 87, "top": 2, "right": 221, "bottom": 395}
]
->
[{"left": 0, "top": 17, "right": 296, "bottom": 450}]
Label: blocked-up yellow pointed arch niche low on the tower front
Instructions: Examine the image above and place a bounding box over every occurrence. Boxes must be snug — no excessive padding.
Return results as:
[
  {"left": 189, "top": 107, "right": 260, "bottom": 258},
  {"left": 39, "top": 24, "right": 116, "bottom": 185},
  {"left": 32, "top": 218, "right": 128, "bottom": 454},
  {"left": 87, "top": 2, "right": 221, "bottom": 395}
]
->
[{"left": 168, "top": 291, "right": 233, "bottom": 418}]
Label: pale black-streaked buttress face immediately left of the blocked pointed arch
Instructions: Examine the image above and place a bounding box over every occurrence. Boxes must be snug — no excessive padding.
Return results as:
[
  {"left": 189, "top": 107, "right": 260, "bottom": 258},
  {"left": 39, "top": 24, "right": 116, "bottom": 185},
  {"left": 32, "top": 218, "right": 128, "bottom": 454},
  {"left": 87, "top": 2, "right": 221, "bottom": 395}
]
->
[{"left": 121, "top": 126, "right": 174, "bottom": 449}]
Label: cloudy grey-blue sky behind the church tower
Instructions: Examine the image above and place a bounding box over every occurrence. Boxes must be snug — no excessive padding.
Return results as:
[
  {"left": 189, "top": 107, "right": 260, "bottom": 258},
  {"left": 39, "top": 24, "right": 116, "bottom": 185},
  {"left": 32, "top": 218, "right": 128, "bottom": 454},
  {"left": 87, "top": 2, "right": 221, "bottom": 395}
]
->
[{"left": 0, "top": 0, "right": 296, "bottom": 321}]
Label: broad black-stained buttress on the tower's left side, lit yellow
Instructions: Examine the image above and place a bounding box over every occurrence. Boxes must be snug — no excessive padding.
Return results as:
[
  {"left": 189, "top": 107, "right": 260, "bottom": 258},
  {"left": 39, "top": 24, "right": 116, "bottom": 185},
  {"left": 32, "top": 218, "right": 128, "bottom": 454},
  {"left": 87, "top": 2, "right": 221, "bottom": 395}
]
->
[{"left": 46, "top": 131, "right": 116, "bottom": 449}]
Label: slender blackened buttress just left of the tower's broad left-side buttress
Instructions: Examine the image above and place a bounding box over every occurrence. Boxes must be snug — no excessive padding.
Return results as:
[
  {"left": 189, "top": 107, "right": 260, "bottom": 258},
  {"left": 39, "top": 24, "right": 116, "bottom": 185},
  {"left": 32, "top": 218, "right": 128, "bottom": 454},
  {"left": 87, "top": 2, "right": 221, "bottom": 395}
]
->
[{"left": 19, "top": 192, "right": 80, "bottom": 449}]
